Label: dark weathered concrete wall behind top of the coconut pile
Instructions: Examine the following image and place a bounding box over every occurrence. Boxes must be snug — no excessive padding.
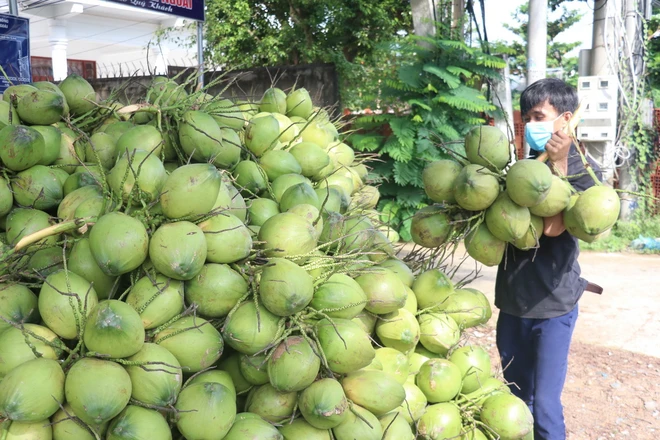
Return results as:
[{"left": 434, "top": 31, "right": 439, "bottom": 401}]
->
[{"left": 90, "top": 64, "right": 341, "bottom": 113}]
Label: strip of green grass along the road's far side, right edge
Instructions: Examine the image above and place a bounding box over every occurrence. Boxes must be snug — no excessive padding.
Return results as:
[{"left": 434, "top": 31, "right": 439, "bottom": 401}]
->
[{"left": 580, "top": 216, "right": 660, "bottom": 254}]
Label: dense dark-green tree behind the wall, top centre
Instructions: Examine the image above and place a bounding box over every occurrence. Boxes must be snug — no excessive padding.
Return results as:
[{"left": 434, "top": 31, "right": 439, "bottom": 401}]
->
[{"left": 199, "top": 0, "right": 412, "bottom": 106}]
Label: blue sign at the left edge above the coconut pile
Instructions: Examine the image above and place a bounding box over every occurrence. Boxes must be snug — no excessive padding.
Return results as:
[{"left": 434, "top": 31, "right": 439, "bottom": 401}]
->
[{"left": 0, "top": 14, "right": 32, "bottom": 92}]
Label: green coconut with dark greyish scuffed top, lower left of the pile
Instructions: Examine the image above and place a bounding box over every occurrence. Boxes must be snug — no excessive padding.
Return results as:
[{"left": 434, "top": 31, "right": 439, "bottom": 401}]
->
[{"left": 83, "top": 299, "right": 145, "bottom": 358}]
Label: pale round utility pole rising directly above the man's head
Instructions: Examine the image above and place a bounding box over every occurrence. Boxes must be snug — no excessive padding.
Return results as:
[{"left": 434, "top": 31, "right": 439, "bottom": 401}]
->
[{"left": 527, "top": 0, "right": 548, "bottom": 86}]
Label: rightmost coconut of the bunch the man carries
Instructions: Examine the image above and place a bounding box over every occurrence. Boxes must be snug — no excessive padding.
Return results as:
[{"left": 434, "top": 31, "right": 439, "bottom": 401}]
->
[{"left": 572, "top": 185, "right": 621, "bottom": 235}]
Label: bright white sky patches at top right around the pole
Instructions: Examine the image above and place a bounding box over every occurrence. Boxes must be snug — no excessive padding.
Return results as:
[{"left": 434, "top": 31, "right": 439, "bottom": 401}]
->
[{"left": 475, "top": 0, "right": 594, "bottom": 56}]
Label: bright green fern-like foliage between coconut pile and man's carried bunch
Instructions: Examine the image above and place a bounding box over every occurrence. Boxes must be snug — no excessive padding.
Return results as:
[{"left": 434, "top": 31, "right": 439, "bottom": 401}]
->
[{"left": 349, "top": 26, "right": 505, "bottom": 240}]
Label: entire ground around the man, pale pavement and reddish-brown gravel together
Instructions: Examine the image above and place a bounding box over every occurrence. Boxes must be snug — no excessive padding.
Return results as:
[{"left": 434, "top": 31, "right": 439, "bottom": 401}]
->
[{"left": 452, "top": 252, "right": 660, "bottom": 440}]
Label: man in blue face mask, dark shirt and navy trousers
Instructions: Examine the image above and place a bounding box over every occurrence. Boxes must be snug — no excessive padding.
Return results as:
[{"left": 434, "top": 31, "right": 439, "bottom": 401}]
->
[{"left": 495, "top": 78, "right": 600, "bottom": 440}]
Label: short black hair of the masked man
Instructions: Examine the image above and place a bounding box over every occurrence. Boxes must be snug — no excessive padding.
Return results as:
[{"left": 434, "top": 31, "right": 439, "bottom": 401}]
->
[{"left": 520, "top": 78, "right": 578, "bottom": 115}]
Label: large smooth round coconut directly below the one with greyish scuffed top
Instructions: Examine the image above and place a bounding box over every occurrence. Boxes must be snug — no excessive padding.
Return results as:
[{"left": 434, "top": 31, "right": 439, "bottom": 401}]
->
[{"left": 64, "top": 357, "right": 132, "bottom": 425}]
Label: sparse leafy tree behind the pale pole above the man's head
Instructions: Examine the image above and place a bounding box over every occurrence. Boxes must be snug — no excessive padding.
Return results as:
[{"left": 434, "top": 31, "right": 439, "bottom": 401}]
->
[{"left": 495, "top": 2, "right": 582, "bottom": 86}]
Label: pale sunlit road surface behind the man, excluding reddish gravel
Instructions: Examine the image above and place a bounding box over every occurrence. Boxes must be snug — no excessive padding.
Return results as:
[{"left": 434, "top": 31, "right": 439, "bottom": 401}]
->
[{"left": 457, "top": 248, "right": 660, "bottom": 358}]
